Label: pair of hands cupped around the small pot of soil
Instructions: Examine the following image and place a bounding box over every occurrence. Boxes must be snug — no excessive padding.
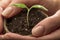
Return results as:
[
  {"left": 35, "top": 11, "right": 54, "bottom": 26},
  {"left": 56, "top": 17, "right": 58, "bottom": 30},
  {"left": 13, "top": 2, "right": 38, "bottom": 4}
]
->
[{"left": 0, "top": 0, "right": 60, "bottom": 40}]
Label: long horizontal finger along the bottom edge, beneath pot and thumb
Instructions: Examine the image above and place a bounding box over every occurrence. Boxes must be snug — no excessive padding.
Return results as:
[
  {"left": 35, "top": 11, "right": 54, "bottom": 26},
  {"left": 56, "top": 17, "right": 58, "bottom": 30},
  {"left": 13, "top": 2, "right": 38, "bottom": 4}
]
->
[{"left": 0, "top": 29, "right": 60, "bottom": 40}]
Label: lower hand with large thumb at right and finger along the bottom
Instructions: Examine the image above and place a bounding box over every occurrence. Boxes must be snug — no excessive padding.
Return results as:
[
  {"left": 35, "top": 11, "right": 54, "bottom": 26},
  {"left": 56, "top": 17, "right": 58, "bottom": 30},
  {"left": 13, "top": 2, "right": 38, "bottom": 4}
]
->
[{"left": 0, "top": 10, "right": 60, "bottom": 40}]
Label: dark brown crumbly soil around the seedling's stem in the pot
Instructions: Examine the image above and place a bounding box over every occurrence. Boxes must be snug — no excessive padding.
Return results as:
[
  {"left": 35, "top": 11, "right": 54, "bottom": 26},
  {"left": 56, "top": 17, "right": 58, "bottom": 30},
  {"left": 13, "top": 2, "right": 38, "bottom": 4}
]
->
[{"left": 6, "top": 9, "right": 46, "bottom": 35}]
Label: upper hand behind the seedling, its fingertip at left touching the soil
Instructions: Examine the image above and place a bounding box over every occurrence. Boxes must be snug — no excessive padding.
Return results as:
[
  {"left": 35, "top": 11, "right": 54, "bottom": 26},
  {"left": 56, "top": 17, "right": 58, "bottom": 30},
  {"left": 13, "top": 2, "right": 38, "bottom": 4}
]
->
[{"left": 0, "top": 0, "right": 60, "bottom": 18}]
